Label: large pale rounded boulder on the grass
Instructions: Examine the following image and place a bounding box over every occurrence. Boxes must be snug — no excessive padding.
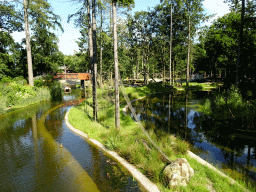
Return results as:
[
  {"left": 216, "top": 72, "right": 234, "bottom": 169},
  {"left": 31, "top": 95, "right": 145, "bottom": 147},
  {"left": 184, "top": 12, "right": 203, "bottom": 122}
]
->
[{"left": 163, "top": 158, "right": 194, "bottom": 187}]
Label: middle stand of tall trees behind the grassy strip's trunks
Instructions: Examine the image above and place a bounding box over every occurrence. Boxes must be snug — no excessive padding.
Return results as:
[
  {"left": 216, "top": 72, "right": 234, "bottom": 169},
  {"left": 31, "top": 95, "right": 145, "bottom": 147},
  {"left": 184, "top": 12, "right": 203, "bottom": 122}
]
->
[{"left": 69, "top": 0, "right": 206, "bottom": 85}]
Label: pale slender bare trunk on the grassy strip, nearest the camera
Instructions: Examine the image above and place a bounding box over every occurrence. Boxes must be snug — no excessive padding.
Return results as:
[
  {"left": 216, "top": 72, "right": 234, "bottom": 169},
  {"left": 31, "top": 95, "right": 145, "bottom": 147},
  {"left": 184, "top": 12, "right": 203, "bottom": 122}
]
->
[{"left": 112, "top": 0, "right": 120, "bottom": 129}]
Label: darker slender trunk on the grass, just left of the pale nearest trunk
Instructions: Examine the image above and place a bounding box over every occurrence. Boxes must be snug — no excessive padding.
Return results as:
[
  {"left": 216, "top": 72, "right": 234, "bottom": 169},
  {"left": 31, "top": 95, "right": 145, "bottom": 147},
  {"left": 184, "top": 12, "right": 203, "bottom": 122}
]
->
[{"left": 92, "top": 0, "right": 98, "bottom": 121}]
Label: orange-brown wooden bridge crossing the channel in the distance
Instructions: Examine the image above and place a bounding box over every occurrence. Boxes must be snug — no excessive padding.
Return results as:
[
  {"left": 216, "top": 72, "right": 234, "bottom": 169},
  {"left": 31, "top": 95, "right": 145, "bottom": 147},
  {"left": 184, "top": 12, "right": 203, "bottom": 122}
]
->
[{"left": 53, "top": 73, "right": 90, "bottom": 81}]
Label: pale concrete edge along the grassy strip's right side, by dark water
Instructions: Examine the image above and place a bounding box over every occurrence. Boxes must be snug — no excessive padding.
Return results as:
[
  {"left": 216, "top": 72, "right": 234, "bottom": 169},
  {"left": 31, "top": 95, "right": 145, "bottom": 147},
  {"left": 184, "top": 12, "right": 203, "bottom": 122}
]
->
[{"left": 123, "top": 92, "right": 250, "bottom": 192}]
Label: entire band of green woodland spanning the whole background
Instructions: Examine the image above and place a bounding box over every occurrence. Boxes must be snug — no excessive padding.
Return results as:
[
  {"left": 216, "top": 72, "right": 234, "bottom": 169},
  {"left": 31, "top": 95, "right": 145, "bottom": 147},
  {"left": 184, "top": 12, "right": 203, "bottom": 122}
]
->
[{"left": 0, "top": 0, "right": 256, "bottom": 90}]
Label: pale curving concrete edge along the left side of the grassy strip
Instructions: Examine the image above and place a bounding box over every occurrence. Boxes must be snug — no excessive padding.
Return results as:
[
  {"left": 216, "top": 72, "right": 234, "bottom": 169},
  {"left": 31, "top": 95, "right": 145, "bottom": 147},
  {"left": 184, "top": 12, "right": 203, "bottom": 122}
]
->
[{"left": 65, "top": 108, "right": 160, "bottom": 192}]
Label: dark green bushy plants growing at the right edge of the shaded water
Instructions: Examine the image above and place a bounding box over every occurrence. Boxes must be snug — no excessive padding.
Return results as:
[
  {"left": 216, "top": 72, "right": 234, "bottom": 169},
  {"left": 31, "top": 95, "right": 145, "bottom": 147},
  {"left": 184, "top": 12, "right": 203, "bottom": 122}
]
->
[{"left": 202, "top": 86, "right": 256, "bottom": 130}]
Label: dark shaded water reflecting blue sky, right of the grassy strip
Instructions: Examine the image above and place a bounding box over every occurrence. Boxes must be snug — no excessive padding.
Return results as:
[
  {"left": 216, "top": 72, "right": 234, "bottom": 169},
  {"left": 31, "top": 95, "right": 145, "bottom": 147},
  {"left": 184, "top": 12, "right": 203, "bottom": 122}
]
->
[{"left": 131, "top": 92, "right": 256, "bottom": 186}]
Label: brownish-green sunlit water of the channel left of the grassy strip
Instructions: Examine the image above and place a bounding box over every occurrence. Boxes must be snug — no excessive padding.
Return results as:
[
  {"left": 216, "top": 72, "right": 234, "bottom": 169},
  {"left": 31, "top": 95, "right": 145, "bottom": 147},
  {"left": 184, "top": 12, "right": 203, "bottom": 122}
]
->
[{"left": 0, "top": 91, "right": 143, "bottom": 192}]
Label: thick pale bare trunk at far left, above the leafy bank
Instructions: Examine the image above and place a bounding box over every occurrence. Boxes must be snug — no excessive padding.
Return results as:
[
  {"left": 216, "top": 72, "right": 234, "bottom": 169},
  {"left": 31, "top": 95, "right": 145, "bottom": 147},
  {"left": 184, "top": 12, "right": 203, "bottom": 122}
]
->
[{"left": 23, "top": 0, "right": 34, "bottom": 86}]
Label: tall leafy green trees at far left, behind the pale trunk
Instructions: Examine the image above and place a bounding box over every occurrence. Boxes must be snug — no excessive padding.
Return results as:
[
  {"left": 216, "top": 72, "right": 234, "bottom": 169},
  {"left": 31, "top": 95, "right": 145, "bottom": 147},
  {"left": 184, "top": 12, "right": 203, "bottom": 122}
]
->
[{"left": 0, "top": 0, "right": 64, "bottom": 82}]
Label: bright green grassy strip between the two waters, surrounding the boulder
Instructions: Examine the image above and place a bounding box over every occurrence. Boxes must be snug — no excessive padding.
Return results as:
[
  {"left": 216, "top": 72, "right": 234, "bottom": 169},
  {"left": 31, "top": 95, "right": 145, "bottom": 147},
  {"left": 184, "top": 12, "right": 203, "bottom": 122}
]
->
[{"left": 69, "top": 87, "right": 253, "bottom": 191}]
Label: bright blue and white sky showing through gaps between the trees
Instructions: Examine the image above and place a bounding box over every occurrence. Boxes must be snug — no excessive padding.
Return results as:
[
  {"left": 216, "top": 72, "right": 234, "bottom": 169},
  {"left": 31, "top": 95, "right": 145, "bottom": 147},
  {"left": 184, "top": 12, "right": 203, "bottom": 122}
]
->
[{"left": 12, "top": 0, "right": 229, "bottom": 55}]
